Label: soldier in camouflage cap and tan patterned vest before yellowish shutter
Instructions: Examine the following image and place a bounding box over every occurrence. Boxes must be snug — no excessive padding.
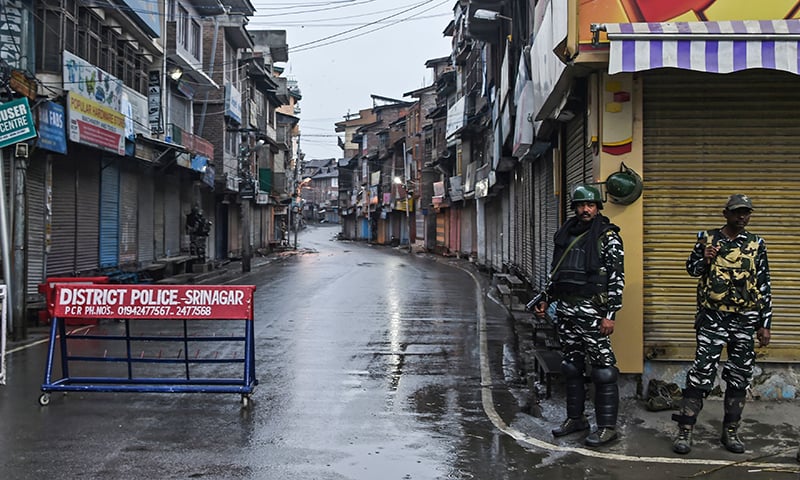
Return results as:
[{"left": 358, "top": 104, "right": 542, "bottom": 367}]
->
[{"left": 672, "top": 193, "right": 772, "bottom": 454}]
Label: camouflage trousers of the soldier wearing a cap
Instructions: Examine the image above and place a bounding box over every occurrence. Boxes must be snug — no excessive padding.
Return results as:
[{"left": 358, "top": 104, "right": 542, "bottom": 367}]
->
[{"left": 686, "top": 309, "right": 756, "bottom": 392}]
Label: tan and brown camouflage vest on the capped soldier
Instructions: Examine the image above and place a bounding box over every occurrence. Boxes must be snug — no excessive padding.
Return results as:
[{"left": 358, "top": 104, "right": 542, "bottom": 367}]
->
[{"left": 697, "top": 230, "right": 761, "bottom": 312}]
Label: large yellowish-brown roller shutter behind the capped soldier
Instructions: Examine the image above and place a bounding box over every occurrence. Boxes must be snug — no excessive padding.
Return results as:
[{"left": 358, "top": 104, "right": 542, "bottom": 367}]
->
[{"left": 642, "top": 71, "right": 800, "bottom": 361}]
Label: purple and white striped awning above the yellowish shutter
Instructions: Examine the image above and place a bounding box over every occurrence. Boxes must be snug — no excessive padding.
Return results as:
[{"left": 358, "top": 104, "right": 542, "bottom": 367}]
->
[{"left": 601, "top": 19, "right": 800, "bottom": 74}]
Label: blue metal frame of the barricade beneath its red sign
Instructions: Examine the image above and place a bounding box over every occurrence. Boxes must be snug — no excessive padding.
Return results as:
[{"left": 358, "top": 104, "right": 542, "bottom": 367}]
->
[{"left": 40, "top": 317, "right": 258, "bottom": 405}]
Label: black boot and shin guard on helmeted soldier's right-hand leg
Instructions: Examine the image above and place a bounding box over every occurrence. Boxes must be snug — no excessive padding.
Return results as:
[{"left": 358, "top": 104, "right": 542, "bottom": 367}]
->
[{"left": 584, "top": 367, "right": 619, "bottom": 447}]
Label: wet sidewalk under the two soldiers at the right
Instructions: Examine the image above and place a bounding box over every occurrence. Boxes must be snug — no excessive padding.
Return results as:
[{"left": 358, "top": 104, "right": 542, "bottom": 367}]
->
[{"left": 494, "top": 284, "right": 800, "bottom": 468}]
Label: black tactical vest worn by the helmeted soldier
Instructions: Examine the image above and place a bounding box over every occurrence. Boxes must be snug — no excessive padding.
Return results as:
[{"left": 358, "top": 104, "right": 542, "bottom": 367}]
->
[{"left": 551, "top": 232, "right": 608, "bottom": 299}]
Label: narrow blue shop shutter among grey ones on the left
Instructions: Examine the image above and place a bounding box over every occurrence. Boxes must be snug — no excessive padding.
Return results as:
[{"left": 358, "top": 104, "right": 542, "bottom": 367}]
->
[{"left": 100, "top": 161, "right": 119, "bottom": 268}]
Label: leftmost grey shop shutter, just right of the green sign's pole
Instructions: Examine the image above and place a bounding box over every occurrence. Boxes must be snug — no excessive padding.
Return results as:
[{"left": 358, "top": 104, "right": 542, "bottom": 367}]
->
[{"left": 27, "top": 157, "right": 47, "bottom": 297}]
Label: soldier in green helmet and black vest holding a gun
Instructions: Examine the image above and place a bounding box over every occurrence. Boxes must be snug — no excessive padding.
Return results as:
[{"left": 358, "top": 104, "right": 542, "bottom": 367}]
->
[{"left": 533, "top": 185, "right": 625, "bottom": 447}]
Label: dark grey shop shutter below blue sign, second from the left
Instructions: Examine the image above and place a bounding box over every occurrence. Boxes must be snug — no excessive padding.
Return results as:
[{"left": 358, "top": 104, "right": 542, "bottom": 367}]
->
[{"left": 47, "top": 158, "right": 76, "bottom": 277}]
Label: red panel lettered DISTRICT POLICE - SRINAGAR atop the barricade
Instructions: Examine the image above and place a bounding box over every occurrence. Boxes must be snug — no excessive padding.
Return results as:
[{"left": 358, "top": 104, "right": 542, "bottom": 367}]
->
[{"left": 54, "top": 284, "right": 256, "bottom": 320}]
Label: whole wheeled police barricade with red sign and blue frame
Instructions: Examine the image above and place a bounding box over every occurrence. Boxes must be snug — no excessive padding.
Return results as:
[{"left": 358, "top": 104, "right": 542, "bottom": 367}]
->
[{"left": 39, "top": 283, "right": 258, "bottom": 407}]
